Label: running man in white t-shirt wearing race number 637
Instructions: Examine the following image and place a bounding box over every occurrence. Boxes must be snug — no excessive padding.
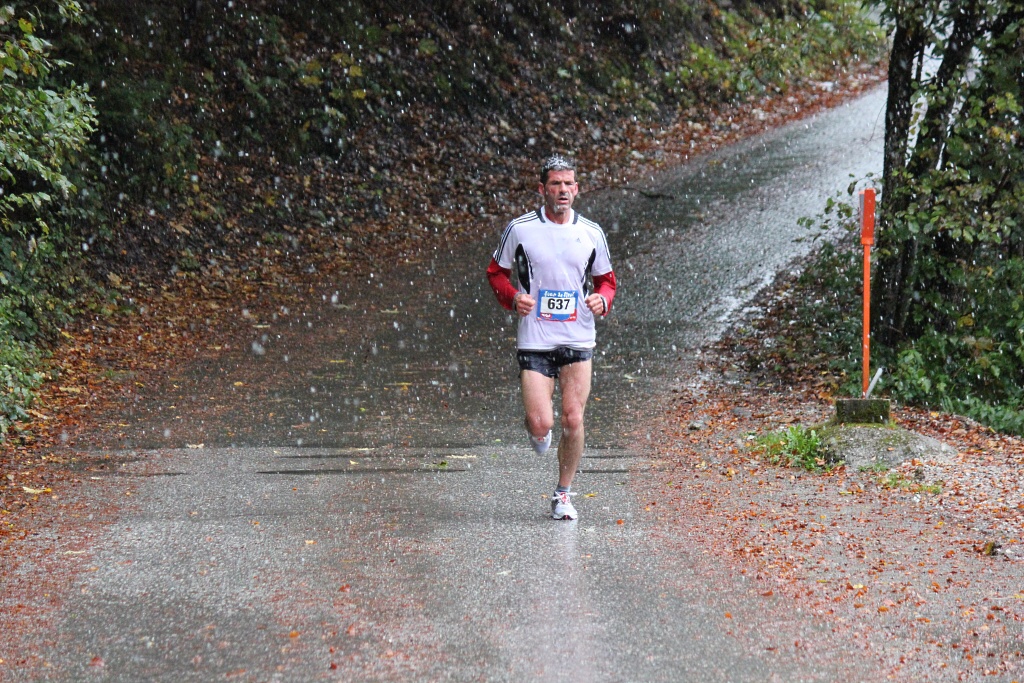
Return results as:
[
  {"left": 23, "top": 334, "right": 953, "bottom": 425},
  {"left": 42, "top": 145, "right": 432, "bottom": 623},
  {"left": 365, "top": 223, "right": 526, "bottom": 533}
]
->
[{"left": 487, "top": 155, "right": 615, "bottom": 519}]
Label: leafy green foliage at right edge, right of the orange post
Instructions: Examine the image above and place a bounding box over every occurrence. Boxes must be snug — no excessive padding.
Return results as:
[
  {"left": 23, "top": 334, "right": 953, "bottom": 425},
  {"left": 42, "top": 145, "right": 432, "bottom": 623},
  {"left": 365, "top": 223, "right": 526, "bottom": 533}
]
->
[{"left": 856, "top": 1, "right": 1024, "bottom": 433}]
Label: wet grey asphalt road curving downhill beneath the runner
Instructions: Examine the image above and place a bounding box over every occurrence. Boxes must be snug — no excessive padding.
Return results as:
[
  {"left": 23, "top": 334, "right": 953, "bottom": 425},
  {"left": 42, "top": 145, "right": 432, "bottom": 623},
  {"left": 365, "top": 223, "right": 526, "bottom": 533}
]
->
[{"left": 24, "top": 85, "right": 884, "bottom": 681}]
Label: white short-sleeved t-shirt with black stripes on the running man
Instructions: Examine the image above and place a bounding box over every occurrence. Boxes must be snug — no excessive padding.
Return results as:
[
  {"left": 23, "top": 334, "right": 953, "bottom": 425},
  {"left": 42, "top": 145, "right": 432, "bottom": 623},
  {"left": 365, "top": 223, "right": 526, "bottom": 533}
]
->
[{"left": 494, "top": 208, "right": 611, "bottom": 351}]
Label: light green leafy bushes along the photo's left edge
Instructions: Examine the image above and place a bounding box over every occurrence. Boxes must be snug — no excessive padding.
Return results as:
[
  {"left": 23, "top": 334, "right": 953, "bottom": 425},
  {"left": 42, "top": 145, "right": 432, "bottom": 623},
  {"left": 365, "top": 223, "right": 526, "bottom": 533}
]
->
[{"left": 0, "top": 0, "right": 96, "bottom": 341}]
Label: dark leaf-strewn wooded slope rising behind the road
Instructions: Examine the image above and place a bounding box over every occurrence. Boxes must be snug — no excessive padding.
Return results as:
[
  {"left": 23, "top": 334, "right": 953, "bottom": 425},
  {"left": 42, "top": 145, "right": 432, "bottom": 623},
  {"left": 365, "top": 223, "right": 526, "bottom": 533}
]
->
[{"left": 49, "top": 0, "right": 881, "bottom": 272}]
